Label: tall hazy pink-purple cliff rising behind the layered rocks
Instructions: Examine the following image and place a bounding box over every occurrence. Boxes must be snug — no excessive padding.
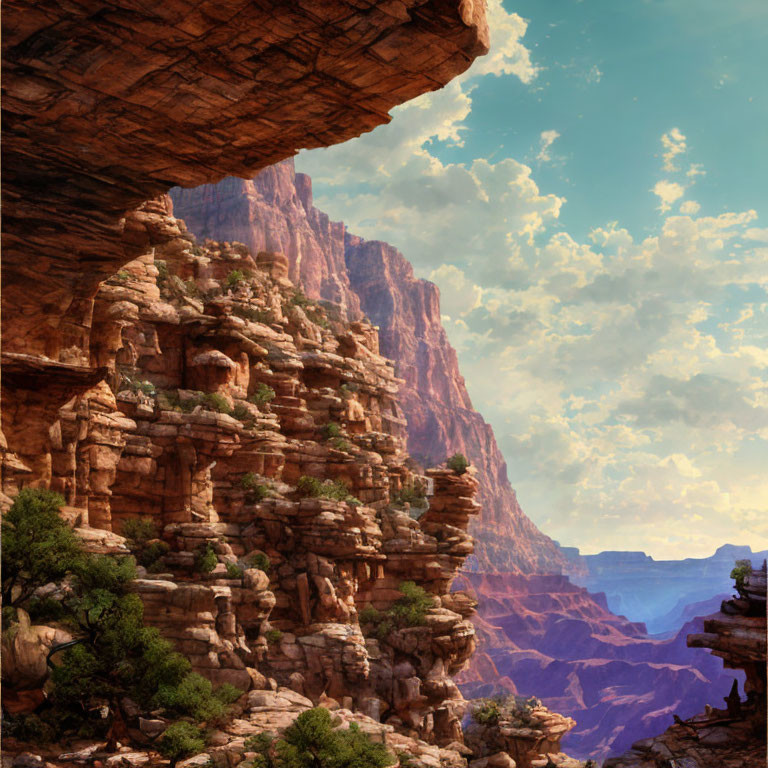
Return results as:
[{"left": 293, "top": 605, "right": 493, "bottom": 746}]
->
[{"left": 171, "top": 160, "right": 566, "bottom": 573}]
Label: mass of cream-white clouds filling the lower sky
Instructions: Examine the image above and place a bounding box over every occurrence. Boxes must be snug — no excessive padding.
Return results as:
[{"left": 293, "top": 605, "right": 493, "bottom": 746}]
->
[{"left": 297, "top": 6, "right": 768, "bottom": 557}]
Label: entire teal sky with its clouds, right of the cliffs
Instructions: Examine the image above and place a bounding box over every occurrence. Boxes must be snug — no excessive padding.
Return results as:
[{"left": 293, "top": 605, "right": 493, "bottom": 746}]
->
[{"left": 297, "top": 0, "right": 768, "bottom": 557}]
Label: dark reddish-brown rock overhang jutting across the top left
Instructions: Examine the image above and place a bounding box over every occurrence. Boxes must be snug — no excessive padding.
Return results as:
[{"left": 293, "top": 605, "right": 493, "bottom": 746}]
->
[{"left": 2, "top": 0, "right": 488, "bottom": 368}]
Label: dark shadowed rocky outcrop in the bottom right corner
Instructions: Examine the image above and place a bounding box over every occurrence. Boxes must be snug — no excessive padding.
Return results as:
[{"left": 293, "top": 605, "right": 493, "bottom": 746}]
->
[{"left": 605, "top": 565, "right": 766, "bottom": 768}]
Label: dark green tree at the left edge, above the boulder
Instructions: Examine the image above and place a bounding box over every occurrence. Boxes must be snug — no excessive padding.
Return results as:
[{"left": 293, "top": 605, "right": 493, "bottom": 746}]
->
[{"left": 2, "top": 488, "right": 83, "bottom": 607}]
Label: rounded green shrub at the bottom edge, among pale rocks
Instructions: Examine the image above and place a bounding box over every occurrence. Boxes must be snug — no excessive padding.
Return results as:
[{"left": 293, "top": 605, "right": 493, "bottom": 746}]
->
[{"left": 245, "top": 707, "right": 395, "bottom": 768}]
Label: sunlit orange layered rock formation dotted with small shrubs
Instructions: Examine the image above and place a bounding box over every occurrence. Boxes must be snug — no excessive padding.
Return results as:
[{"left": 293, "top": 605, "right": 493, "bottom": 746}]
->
[{"left": 4, "top": 200, "right": 480, "bottom": 756}]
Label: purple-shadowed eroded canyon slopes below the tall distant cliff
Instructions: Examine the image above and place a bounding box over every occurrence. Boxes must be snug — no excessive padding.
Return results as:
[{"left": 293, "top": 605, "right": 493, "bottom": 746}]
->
[{"left": 455, "top": 573, "right": 742, "bottom": 758}]
